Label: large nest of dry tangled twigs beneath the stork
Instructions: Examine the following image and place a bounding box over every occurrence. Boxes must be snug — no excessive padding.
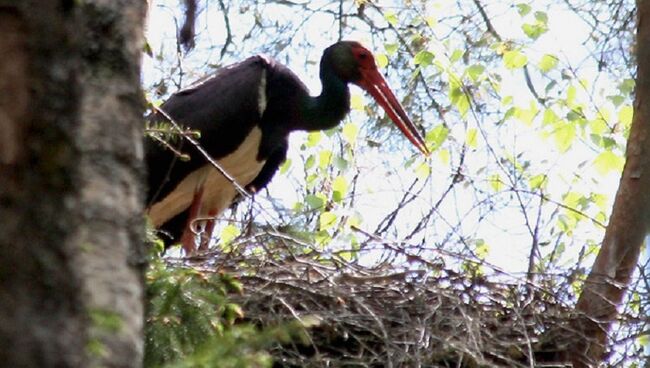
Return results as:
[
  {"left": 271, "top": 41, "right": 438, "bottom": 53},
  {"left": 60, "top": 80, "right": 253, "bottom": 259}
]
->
[{"left": 175, "top": 233, "right": 644, "bottom": 367}]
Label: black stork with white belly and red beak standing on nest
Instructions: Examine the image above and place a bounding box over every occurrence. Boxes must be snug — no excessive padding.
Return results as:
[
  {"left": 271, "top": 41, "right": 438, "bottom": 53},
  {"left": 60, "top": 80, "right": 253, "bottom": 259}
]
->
[{"left": 146, "top": 41, "right": 429, "bottom": 254}]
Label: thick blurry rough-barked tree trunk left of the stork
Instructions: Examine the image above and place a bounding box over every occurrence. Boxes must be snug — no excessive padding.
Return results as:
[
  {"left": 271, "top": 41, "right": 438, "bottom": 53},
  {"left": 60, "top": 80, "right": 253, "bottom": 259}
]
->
[{"left": 0, "top": 0, "right": 146, "bottom": 367}]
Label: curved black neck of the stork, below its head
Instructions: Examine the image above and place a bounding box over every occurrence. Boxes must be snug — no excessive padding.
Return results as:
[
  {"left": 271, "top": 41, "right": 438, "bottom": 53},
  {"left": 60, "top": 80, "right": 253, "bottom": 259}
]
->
[{"left": 298, "top": 63, "right": 350, "bottom": 131}]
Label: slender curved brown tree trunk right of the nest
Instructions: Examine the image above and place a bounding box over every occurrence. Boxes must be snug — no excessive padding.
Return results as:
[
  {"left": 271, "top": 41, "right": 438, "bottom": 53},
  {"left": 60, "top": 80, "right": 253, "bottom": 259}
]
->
[{"left": 568, "top": 0, "right": 650, "bottom": 367}]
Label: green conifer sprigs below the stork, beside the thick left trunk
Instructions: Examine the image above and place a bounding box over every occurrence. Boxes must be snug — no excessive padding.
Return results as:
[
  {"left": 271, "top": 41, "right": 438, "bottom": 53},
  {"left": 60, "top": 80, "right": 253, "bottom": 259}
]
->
[{"left": 144, "top": 257, "right": 306, "bottom": 368}]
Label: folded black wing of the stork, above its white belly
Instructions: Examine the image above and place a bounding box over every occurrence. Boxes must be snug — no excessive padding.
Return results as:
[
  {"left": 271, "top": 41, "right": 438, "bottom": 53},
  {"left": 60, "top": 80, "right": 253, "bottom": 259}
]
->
[{"left": 145, "top": 56, "right": 273, "bottom": 205}]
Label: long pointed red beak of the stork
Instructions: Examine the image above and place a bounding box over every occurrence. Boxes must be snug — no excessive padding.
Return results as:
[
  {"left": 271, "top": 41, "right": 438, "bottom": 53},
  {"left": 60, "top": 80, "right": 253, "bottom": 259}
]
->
[{"left": 356, "top": 69, "right": 430, "bottom": 156}]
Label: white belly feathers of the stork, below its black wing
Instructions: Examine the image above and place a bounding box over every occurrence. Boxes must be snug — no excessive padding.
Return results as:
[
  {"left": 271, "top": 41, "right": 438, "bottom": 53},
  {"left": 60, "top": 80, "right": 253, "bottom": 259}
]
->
[{"left": 148, "top": 127, "right": 265, "bottom": 227}]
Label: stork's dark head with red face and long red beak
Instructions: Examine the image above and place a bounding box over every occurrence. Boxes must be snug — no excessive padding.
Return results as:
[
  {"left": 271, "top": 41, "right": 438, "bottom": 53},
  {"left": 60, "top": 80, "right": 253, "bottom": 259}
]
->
[{"left": 321, "top": 41, "right": 429, "bottom": 156}]
